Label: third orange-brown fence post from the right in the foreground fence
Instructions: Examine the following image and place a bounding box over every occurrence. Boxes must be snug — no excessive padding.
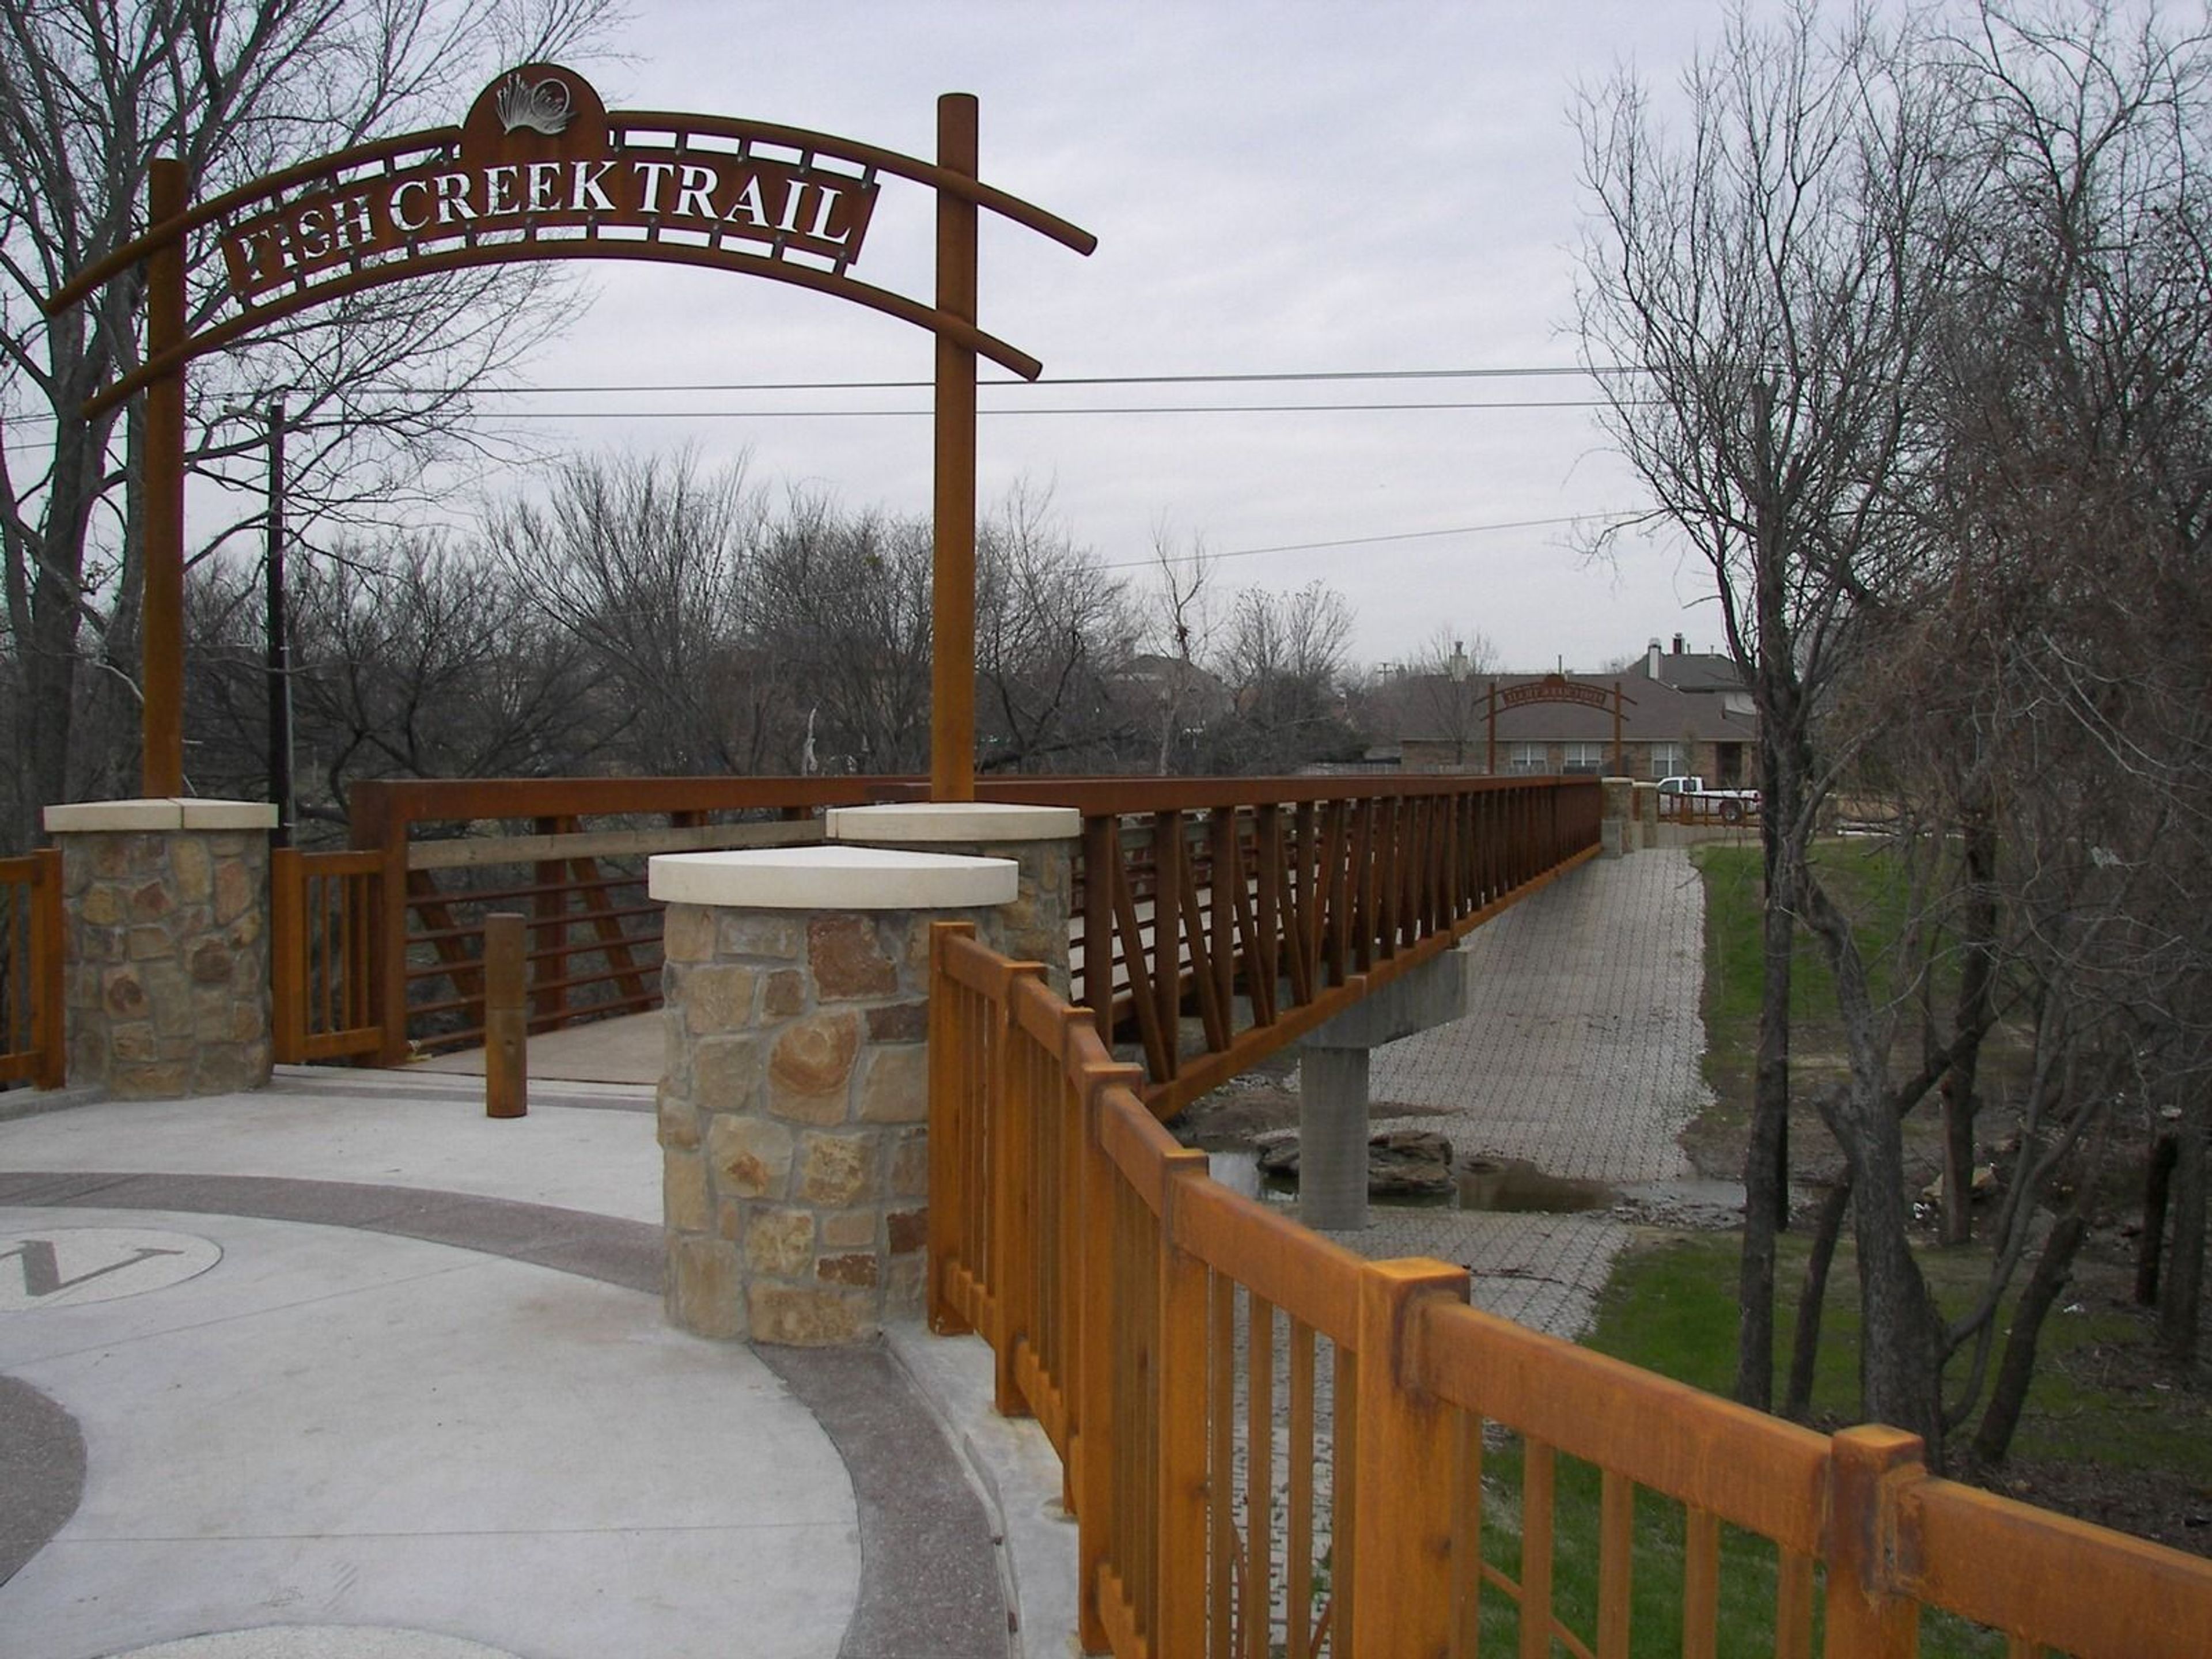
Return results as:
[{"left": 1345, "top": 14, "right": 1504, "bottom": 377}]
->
[{"left": 1153, "top": 1153, "right": 1228, "bottom": 1654}]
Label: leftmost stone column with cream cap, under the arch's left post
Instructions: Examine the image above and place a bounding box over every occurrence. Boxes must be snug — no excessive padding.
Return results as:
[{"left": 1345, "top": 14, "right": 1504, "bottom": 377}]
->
[{"left": 47, "top": 798, "right": 276, "bottom": 1099}]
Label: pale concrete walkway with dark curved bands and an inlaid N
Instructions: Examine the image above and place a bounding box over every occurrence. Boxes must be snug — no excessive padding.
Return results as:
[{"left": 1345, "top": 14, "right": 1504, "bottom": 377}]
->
[{"left": 0, "top": 1071, "right": 1009, "bottom": 1659}]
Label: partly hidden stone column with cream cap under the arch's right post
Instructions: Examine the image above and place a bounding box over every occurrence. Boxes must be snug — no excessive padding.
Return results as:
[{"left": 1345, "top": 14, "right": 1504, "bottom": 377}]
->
[{"left": 823, "top": 801, "right": 1084, "bottom": 998}]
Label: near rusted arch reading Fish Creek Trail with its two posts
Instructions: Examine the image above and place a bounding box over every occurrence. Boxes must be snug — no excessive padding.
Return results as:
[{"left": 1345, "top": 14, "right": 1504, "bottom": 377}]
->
[{"left": 47, "top": 64, "right": 1097, "bottom": 801}]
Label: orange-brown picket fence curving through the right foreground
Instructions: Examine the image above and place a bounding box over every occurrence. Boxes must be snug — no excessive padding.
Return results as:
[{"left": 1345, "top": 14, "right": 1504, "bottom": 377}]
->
[{"left": 929, "top": 922, "right": 2212, "bottom": 1659}]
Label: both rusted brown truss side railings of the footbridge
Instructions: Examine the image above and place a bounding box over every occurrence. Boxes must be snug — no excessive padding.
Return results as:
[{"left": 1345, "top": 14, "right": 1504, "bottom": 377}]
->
[{"left": 272, "top": 777, "right": 1599, "bottom": 1084}]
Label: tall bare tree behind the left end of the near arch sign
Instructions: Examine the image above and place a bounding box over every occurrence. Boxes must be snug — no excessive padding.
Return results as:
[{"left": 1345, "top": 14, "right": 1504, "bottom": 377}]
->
[{"left": 0, "top": 0, "right": 611, "bottom": 840}]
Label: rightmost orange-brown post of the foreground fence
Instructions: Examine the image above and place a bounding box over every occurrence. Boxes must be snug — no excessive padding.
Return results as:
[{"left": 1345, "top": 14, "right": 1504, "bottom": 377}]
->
[{"left": 1827, "top": 1422, "right": 1927, "bottom": 1659}]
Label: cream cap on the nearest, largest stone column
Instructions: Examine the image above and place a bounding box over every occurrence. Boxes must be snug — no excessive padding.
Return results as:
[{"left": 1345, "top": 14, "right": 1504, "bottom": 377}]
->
[{"left": 646, "top": 847, "right": 1020, "bottom": 909}]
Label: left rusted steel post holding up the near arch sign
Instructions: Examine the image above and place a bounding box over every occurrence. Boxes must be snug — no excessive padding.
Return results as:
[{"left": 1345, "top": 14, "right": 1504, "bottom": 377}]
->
[{"left": 139, "top": 161, "right": 190, "bottom": 796}]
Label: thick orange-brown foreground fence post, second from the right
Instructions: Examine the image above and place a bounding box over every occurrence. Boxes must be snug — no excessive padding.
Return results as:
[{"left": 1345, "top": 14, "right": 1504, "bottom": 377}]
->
[{"left": 1347, "top": 1261, "right": 1473, "bottom": 1659}]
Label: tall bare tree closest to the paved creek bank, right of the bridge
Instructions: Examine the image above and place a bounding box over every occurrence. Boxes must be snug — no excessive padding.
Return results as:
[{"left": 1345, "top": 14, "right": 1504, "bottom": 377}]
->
[{"left": 1577, "top": 7, "right": 1946, "bottom": 1456}]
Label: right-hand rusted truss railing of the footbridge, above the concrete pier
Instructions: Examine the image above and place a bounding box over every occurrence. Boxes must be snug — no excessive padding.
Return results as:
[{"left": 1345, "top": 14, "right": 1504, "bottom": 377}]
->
[{"left": 1039, "top": 777, "right": 1601, "bottom": 1117}]
